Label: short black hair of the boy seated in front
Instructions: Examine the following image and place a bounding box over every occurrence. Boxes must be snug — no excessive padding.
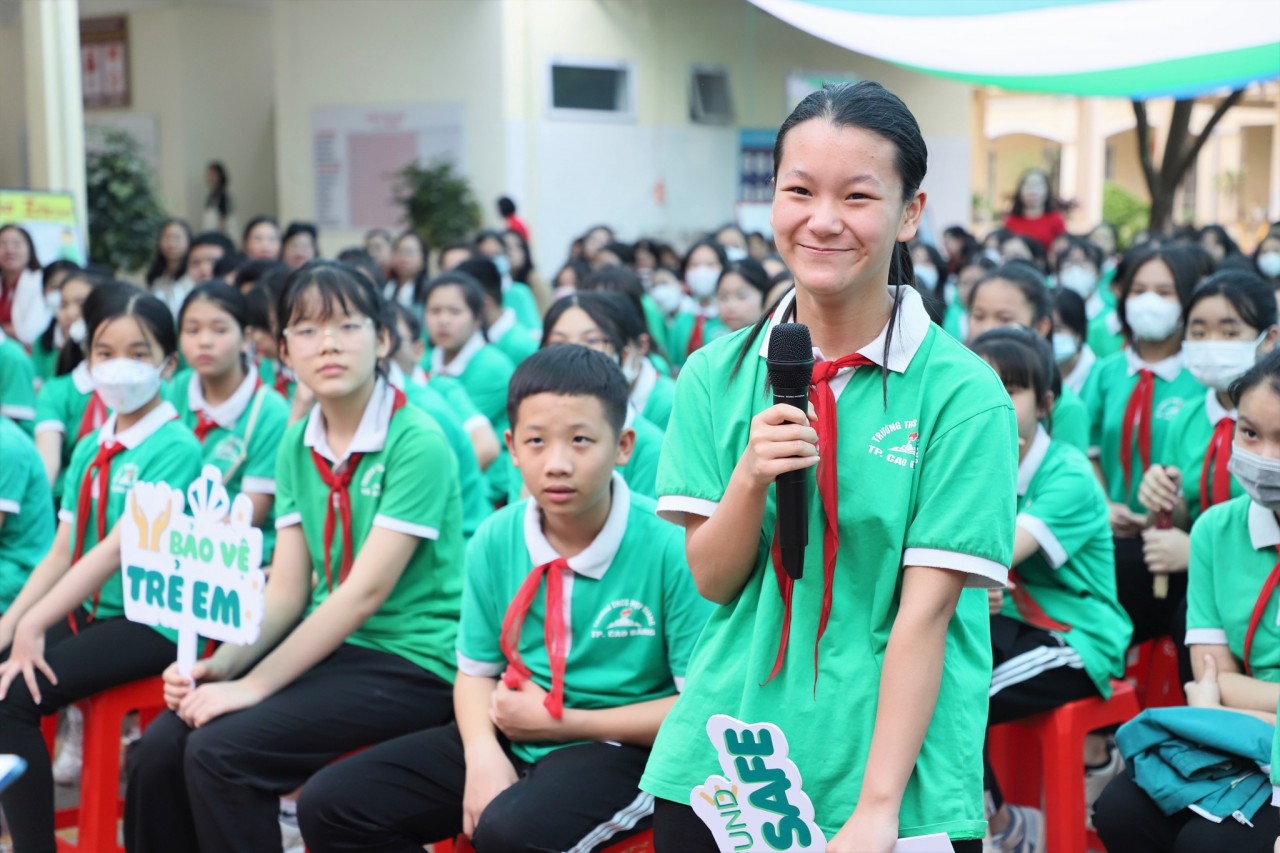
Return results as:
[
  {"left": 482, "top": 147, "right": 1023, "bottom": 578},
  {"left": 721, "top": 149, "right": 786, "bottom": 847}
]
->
[{"left": 507, "top": 346, "right": 631, "bottom": 435}]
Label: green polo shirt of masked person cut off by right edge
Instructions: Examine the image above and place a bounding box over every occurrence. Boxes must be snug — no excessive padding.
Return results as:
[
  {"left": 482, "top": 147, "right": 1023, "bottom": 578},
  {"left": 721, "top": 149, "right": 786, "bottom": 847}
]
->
[{"left": 1187, "top": 497, "right": 1280, "bottom": 684}]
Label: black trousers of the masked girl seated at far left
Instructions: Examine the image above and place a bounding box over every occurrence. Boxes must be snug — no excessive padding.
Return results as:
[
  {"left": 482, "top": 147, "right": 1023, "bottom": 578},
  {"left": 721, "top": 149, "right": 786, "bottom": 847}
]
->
[{"left": 0, "top": 611, "right": 178, "bottom": 853}]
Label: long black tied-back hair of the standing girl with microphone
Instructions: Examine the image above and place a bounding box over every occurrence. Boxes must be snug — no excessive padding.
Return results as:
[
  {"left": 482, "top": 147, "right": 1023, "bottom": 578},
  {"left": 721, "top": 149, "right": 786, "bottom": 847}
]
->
[{"left": 733, "top": 79, "right": 929, "bottom": 406}]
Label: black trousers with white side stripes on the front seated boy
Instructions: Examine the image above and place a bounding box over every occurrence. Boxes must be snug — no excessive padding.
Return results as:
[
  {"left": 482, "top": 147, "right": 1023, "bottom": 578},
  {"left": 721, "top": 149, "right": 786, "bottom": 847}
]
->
[{"left": 298, "top": 724, "right": 653, "bottom": 853}]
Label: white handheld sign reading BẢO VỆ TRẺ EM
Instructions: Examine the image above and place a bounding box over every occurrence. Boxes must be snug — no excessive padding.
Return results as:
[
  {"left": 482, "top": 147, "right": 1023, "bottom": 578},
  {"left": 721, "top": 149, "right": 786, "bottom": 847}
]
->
[{"left": 120, "top": 465, "right": 266, "bottom": 676}]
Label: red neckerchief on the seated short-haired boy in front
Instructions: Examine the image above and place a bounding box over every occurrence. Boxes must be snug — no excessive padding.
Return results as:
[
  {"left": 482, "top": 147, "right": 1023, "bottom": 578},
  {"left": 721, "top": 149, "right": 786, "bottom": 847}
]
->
[{"left": 498, "top": 557, "right": 573, "bottom": 720}]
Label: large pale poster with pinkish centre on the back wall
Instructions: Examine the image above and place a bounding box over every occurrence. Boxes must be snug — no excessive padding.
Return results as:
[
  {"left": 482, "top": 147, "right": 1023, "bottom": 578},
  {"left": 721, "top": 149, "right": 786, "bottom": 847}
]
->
[{"left": 311, "top": 104, "right": 466, "bottom": 231}]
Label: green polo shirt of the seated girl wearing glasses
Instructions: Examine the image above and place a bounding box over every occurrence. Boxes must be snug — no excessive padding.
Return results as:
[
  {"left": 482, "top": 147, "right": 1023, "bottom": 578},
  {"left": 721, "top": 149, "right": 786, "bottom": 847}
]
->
[{"left": 275, "top": 382, "right": 462, "bottom": 681}]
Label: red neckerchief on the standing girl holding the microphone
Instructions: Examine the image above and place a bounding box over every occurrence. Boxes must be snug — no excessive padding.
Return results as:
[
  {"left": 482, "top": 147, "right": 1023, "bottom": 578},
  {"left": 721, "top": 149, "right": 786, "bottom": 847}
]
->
[{"left": 764, "top": 352, "right": 876, "bottom": 686}]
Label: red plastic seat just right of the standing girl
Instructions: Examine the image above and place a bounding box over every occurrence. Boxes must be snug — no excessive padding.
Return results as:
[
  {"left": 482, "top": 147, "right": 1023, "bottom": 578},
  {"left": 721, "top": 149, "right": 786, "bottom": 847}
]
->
[{"left": 987, "top": 680, "right": 1140, "bottom": 853}]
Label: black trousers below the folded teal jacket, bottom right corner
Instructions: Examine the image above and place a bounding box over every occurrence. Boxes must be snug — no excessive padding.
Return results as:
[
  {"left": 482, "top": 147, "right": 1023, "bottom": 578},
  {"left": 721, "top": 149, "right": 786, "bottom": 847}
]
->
[{"left": 1093, "top": 774, "right": 1280, "bottom": 853}]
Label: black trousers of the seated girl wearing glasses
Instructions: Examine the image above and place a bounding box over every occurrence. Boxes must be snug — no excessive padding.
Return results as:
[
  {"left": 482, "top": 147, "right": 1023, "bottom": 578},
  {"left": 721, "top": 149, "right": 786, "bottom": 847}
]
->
[{"left": 124, "top": 643, "right": 453, "bottom": 853}]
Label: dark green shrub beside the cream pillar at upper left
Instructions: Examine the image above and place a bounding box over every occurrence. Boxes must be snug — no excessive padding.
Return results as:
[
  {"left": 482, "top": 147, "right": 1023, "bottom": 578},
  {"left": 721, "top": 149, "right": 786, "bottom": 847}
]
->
[{"left": 84, "top": 131, "right": 165, "bottom": 272}]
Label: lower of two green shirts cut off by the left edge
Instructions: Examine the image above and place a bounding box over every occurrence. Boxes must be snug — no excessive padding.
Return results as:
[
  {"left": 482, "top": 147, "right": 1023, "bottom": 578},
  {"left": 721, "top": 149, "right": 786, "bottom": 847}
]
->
[{"left": 0, "top": 418, "right": 55, "bottom": 604}]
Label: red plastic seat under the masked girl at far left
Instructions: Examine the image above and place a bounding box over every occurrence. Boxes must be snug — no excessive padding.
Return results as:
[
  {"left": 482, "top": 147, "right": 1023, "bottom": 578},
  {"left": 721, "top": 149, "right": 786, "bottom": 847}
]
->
[{"left": 46, "top": 676, "right": 165, "bottom": 853}]
